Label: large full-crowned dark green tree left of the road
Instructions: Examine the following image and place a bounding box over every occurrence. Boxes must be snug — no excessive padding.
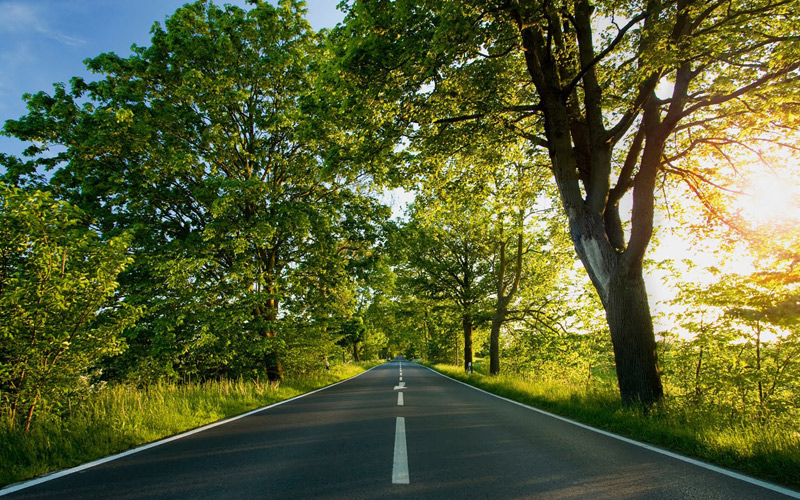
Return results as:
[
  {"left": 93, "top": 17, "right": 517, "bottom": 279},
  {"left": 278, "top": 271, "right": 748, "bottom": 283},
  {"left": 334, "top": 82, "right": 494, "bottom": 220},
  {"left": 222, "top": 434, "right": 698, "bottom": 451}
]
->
[{"left": 0, "top": 0, "right": 387, "bottom": 379}]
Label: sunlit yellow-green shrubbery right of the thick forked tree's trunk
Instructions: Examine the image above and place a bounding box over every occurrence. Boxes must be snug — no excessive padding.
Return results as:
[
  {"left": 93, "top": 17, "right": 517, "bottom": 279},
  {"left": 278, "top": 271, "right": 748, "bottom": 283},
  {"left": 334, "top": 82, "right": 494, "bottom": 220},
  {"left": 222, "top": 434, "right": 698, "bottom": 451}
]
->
[{"left": 666, "top": 273, "right": 800, "bottom": 422}]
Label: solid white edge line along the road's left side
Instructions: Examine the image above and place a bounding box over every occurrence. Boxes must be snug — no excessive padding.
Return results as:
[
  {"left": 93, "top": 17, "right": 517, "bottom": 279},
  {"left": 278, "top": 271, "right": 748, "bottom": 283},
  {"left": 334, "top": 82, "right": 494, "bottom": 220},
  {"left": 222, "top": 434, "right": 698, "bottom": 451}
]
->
[{"left": 0, "top": 365, "right": 382, "bottom": 497}]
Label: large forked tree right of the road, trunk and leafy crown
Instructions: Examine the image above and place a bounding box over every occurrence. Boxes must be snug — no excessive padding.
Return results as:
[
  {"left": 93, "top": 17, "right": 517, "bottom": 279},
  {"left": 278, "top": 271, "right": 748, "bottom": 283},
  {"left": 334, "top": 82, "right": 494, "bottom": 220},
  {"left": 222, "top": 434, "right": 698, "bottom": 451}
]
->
[{"left": 337, "top": 0, "right": 800, "bottom": 404}]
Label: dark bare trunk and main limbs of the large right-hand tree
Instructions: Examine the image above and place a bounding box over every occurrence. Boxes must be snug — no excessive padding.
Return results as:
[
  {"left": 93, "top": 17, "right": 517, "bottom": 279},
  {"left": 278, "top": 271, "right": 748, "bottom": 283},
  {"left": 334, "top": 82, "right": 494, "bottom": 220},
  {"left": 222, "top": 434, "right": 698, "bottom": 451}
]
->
[{"left": 512, "top": 0, "right": 664, "bottom": 405}]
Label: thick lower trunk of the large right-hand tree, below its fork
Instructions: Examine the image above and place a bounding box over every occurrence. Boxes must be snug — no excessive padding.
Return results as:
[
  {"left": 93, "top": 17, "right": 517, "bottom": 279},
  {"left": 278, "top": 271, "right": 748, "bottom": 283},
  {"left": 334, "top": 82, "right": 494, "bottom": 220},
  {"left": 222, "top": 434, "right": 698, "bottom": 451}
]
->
[{"left": 603, "top": 267, "right": 664, "bottom": 405}]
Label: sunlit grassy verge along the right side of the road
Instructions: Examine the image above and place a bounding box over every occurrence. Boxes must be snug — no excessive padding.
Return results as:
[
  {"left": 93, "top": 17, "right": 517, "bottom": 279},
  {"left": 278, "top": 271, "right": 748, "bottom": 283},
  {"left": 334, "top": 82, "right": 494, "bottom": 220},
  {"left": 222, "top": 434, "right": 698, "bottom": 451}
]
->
[{"left": 432, "top": 362, "right": 800, "bottom": 489}]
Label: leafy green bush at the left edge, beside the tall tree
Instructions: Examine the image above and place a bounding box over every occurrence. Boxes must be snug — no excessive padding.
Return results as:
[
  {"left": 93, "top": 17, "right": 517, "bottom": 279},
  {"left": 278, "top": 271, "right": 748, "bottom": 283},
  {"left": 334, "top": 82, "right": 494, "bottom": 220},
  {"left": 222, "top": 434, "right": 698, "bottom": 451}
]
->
[{"left": 0, "top": 184, "right": 138, "bottom": 430}]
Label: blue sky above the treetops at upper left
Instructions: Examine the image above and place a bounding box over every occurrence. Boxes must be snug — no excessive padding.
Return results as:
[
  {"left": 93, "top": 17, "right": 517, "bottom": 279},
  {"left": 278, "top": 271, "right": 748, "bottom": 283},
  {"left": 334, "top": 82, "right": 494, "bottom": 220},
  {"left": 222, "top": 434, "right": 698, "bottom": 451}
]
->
[{"left": 0, "top": 0, "right": 343, "bottom": 155}]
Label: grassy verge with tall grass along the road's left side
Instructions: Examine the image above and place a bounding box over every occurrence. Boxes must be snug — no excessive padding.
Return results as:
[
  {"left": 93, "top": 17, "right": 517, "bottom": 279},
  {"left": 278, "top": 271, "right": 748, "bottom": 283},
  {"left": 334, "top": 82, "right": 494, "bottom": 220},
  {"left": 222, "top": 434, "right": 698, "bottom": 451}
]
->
[{"left": 0, "top": 363, "right": 376, "bottom": 486}]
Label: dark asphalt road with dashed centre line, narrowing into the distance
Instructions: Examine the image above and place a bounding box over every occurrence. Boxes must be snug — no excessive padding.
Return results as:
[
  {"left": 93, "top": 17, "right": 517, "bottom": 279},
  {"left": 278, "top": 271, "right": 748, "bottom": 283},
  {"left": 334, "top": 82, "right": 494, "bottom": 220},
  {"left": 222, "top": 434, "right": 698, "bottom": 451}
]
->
[{"left": 0, "top": 358, "right": 800, "bottom": 500}]
